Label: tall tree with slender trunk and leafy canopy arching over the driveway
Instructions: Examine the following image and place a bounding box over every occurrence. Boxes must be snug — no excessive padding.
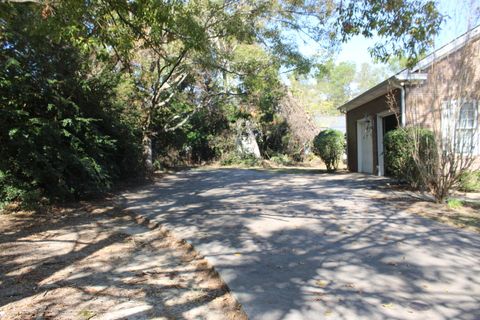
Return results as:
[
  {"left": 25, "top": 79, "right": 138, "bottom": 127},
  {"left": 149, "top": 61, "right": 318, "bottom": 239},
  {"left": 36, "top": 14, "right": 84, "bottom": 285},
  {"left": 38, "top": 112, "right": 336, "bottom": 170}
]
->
[{"left": 20, "top": 0, "right": 442, "bottom": 167}]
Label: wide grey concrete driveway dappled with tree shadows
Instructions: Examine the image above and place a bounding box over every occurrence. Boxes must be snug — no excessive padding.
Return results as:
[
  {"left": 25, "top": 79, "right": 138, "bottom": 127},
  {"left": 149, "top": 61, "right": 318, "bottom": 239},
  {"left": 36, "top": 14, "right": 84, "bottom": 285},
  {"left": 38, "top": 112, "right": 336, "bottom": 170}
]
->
[{"left": 119, "top": 169, "right": 480, "bottom": 320}]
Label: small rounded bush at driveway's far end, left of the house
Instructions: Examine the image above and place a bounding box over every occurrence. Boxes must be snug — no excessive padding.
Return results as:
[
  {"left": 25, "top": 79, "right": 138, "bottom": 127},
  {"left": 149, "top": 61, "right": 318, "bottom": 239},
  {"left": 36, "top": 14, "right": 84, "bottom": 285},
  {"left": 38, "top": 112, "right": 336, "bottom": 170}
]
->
[{"left": 313, "top": 129, "right": 345, "bottom": 172}]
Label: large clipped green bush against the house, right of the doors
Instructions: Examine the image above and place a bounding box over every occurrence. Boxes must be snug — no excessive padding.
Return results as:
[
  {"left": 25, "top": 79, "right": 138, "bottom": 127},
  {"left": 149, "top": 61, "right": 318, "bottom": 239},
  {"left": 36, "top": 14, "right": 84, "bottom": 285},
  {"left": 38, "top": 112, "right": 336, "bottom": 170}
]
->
[{"left": 384, "top": 128, "right": 436, "bottom": 188}]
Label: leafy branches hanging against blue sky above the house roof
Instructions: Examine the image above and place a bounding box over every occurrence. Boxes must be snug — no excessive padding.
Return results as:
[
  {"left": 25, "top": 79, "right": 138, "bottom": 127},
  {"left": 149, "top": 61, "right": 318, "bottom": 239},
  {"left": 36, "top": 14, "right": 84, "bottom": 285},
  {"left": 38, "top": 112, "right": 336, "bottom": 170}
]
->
[{"left": 337, "top": 0, "right": 443, "bottom": 66}]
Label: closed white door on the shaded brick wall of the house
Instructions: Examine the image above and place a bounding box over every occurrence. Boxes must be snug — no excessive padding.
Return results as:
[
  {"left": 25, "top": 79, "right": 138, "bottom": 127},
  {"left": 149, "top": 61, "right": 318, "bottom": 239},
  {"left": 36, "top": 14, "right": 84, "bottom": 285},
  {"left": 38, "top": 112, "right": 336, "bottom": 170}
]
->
[{"left": 357, "top": 120, "right": 373, "bottom": 173}]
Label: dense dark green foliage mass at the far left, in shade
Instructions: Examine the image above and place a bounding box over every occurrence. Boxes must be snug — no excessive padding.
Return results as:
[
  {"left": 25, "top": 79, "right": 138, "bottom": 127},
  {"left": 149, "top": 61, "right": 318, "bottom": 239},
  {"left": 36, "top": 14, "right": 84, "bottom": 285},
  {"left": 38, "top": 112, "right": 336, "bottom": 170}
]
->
[{"left": 0, "top": 6, "right": 140, "bottom": 208}]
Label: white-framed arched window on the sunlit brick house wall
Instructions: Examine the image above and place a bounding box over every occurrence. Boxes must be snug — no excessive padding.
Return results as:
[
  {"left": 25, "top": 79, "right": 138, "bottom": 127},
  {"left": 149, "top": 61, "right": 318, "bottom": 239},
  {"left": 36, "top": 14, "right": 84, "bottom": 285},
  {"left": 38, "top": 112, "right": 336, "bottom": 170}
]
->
[{"left": 455, "top": 101, "right": 478, "bottom": 154}]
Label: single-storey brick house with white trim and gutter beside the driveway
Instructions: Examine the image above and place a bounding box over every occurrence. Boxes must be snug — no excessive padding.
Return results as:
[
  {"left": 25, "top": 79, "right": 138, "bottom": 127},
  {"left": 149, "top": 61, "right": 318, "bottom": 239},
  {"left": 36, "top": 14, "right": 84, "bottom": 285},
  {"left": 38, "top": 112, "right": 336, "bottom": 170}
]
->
[{"left": 339, "top": 26, "right": 480, "bottom": 175}]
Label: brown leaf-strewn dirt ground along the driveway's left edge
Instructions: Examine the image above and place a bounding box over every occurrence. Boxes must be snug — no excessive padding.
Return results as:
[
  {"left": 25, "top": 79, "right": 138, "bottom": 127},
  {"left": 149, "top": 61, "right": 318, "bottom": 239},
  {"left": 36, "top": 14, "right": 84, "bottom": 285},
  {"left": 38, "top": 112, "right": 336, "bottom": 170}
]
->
[{"left": 0, "top": 203, "right": 246, "bottom": 320}]
